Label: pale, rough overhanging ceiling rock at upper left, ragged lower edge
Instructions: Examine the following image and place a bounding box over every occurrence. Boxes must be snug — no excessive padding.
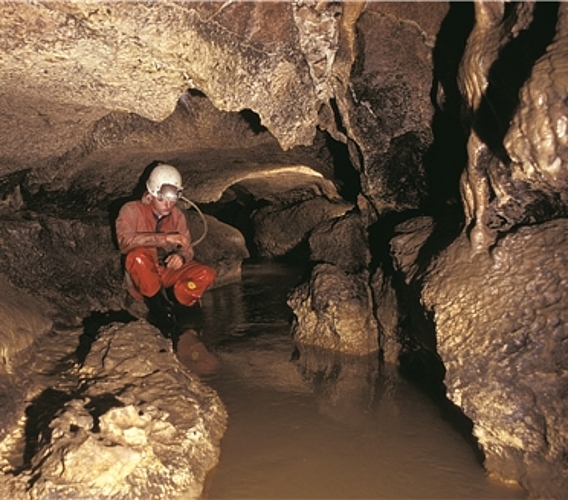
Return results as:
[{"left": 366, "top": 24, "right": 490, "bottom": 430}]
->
[{"left": 0, "top": 1, "right": 317, "bottom": 164}]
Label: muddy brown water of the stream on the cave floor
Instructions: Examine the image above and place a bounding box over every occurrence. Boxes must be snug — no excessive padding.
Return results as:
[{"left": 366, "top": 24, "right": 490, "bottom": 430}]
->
[{"left": 189, "top": 263, "right": 527, "bottom": 500}]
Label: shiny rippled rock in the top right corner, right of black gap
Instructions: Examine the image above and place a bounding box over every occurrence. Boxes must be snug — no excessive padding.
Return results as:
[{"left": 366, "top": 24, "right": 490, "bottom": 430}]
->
[{"left": 502, "top": 3, "right": 568, "bottom": 223}]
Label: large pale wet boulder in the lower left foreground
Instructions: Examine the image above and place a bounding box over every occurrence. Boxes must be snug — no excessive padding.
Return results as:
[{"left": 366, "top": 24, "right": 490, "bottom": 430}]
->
[{"left": 0, "top": 321, "right": 227, "bottom": 499}]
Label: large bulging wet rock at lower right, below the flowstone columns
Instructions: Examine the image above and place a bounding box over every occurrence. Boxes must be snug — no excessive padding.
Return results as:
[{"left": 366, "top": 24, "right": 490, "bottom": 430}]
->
[{"left": 423, "top": 219, "right": 568, "bottom": 498}]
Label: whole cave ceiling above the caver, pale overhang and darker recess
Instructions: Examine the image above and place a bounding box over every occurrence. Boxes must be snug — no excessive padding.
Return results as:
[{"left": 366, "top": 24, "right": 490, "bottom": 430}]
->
[{"left": 0, "top": 1, "right": 342, "bottom": 205}]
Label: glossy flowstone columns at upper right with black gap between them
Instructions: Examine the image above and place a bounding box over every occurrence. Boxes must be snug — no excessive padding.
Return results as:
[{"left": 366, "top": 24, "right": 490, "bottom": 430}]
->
[{"left": 459, "top": 2, "right": 568, "bottom": 252}]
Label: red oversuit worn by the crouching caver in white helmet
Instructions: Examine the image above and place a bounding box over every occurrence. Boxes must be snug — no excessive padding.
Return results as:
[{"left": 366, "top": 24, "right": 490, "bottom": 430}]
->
[{"left": 116, "top": 198, "right": 217, "bottom": 306}]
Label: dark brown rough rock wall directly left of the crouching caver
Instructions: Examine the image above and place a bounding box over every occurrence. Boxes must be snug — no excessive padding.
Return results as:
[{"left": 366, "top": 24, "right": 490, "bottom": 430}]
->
[{"left": 0, "top": 214, "right": 122, "bottom": 324}]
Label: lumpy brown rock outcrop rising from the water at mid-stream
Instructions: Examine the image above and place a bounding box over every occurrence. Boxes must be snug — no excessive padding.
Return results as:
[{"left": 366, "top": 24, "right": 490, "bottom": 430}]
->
[{"left": 288, "top": 207, "right": 382, "bottom": 357}]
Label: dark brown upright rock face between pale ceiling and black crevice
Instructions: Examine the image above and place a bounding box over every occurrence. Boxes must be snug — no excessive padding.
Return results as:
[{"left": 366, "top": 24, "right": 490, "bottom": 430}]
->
[{"left": 338, "top": 2, "right": 447, "bottom": 213}]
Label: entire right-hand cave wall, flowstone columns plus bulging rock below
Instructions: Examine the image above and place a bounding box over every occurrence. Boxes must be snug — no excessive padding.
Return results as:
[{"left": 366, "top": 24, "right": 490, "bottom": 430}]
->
[{"left": 422, "top": 2, "right": 568, "bottom": 498}]
